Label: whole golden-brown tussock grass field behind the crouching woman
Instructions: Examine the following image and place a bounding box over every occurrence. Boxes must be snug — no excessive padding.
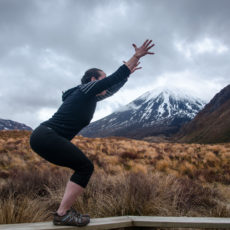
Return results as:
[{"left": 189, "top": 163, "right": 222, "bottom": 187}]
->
[{"left": 0, "top": 131, "right": 230, "bottom": 227}]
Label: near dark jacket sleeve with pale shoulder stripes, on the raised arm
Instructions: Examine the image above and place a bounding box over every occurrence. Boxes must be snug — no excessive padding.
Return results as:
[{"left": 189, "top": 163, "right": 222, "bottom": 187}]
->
[{"left": 80, "top": 64, "right": 131, "bottom": 96}]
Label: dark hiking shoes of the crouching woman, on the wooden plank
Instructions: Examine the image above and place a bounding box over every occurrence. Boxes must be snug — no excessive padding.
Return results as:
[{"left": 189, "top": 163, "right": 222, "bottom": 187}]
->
[{"left": 53, "top": 208, "right": 90, "bottom": 226}]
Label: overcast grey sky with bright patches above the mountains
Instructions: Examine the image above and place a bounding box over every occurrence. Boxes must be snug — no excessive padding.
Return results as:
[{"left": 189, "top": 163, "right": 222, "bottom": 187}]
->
[{"left": 0, "top": 0, "right": 230, "bottom": 129}]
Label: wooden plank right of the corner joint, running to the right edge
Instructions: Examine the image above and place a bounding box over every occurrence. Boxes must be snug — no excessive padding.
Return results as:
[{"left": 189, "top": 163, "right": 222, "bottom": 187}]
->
[{"left": 129, "top": 216, "right": 230, "bottom": 229}]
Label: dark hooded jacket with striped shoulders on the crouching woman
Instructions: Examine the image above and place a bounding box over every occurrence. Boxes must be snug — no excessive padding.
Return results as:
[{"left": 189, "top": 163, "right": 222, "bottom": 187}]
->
[{"left": 41, "top": 64, "right": 130, "bottom": 140}]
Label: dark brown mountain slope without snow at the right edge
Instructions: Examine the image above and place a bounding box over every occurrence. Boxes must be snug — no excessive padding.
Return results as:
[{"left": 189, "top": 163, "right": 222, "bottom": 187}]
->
[{"left": 175, "top": 85, "right": 230, "bottom": 143}]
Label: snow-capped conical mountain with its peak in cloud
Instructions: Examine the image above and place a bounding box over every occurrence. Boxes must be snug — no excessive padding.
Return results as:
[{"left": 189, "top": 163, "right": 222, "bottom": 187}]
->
[{"left": 79, "top": 89, "right": 206, "bottom": 139}]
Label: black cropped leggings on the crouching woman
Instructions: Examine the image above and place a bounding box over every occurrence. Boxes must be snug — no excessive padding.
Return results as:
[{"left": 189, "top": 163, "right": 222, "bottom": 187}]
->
[{"left": 30, "top": 125, "right": 94, "bottom": 188}]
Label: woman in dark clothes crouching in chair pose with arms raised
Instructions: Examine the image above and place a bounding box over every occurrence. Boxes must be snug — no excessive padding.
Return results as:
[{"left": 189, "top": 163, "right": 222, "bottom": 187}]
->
[{"left": 30, "top": 40, "right": 154, "bottom": 226}]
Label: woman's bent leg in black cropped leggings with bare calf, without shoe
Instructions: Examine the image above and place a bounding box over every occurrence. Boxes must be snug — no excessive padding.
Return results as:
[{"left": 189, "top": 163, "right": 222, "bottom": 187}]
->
[{"left": 30, "top": 126, "right": 94, "bottom": 215}]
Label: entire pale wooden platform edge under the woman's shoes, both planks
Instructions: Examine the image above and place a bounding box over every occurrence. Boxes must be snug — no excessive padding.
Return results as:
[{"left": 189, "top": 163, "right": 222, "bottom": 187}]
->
[{"left": 0, "top": 216, "right": 230, "bottom": 230}]
